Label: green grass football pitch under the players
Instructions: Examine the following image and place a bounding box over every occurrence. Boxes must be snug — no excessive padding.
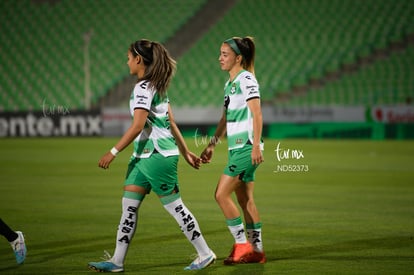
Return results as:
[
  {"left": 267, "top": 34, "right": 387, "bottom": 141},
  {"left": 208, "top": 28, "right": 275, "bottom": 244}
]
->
[{"left": 0, "top": 138, "right": 414, "bottom": 275}]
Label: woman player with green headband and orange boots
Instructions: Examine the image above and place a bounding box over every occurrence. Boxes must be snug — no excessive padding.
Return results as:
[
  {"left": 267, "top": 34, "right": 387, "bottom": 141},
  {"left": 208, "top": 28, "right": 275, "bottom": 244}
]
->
[{"left": 201, "top": 37, "right": 266, "bottom": 264}]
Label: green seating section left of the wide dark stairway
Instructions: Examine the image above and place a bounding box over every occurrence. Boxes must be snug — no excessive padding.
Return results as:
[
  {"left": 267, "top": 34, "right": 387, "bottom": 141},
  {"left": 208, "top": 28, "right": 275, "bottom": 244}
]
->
[{"left": 0, "top": 0, "right": 205, "bottom": 111}]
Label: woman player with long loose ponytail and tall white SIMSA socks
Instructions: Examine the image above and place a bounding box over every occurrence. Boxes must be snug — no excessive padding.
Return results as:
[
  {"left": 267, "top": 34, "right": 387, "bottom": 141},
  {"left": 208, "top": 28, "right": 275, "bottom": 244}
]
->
[{"left": 89, "top": 39, "right": 216, "bottom": 272}]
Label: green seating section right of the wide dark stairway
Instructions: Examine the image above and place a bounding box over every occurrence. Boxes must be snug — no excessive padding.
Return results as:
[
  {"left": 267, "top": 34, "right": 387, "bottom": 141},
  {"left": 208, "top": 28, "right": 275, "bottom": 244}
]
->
[{"left": 170, "top": 0, "right": 414, "bottom": 106}]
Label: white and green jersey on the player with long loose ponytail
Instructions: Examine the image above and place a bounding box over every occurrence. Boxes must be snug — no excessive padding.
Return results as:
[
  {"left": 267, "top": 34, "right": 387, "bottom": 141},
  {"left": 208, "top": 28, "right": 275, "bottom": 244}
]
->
[{"left": 129, "top": 80, "right": 179, "bottom": 158}]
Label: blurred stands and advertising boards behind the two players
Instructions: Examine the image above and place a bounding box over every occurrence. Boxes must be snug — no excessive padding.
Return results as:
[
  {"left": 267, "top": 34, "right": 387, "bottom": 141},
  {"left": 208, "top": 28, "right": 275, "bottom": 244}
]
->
[{"left": 0, "top": 0, "right": 414, "bottom": 139}]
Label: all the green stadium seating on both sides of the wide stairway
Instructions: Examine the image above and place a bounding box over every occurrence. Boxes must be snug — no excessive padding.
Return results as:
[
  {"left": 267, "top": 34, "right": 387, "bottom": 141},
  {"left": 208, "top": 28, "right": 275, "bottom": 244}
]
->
[{"left": 0, "top": 0, "right": 414, "bottom": 111}]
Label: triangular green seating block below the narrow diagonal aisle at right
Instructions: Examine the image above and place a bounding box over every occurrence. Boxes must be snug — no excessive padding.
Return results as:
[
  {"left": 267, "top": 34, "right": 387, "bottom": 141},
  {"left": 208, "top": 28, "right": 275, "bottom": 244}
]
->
[{"left": 289, "top": 45, "right": 414, "bottom": 105}]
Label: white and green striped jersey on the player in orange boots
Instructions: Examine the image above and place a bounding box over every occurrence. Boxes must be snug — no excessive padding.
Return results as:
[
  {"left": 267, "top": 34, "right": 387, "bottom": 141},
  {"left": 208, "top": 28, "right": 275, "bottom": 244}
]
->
[{"left": 224, "top": 70, "right": 263, "bottom": 150}]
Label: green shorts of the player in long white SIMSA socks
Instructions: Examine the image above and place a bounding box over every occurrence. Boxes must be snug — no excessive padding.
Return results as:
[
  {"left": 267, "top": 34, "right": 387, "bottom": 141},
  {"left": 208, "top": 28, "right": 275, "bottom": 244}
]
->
[{"left": 124, "top": 153, "right": 179, "bottom": 196}]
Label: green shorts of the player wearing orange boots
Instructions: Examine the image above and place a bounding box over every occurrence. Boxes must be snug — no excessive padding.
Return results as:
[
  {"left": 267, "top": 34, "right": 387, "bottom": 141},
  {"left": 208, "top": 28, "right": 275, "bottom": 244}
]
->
[{"left": 224, "top": 144, "right": 259, "bottom": 183}]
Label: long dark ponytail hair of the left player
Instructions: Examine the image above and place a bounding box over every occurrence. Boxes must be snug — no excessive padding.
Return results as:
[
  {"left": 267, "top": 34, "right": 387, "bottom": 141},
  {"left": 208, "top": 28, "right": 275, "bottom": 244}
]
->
[{"left": 129, "top": 39, "right": 176, "bottom": 97}]
